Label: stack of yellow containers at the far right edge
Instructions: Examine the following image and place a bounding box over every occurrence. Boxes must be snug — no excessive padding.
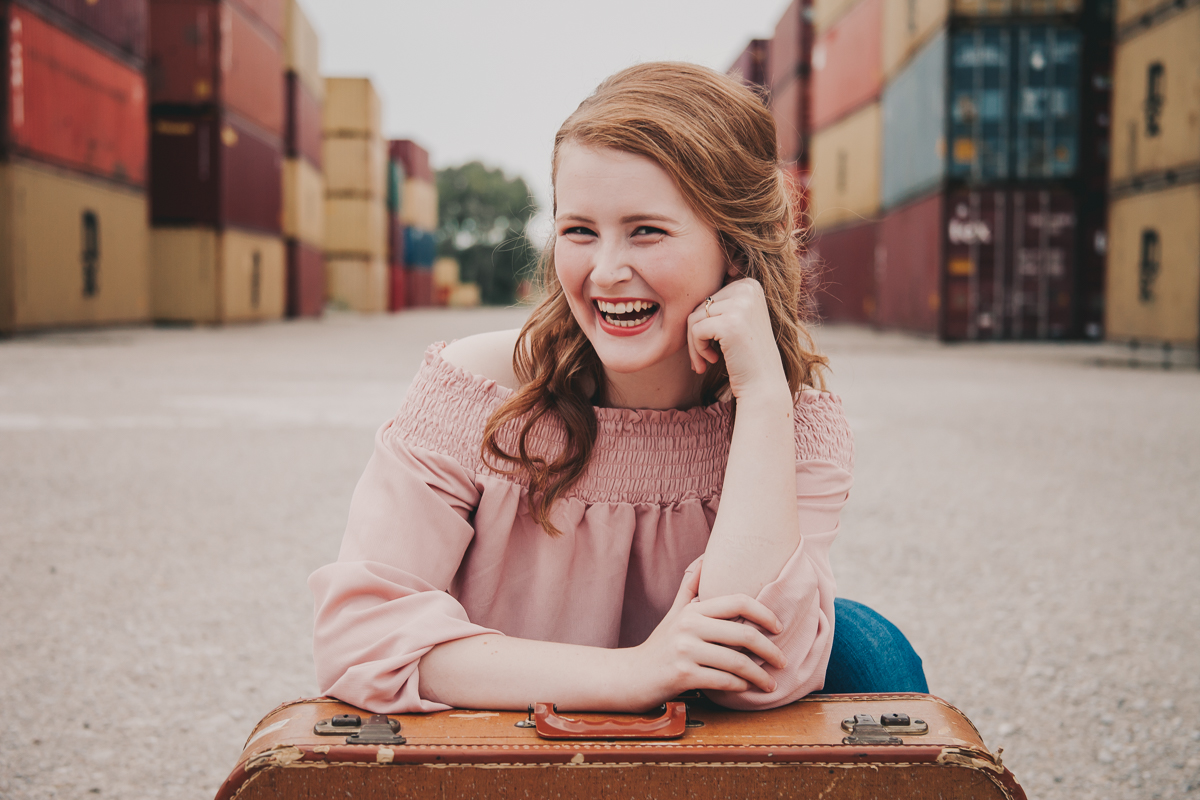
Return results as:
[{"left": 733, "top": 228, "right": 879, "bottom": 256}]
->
[{"left": 1105, "top": 0, "right": 1200, "bottom": 347}]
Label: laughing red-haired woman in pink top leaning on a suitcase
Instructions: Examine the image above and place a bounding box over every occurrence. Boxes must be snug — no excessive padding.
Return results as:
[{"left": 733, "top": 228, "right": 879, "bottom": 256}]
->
[{"left": 310, "top": 64, "right": 924, "bottom": 712}]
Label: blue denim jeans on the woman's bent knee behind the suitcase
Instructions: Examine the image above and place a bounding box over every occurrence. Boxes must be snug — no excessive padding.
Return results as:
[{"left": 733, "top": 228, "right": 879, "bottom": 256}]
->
[{"left": 821, "top": 597, "right": 929, "bottom": 694}]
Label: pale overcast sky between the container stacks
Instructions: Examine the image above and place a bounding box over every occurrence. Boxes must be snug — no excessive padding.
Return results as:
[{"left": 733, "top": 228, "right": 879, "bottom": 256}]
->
[{"left": 300, "top": 0, "right": 788, "bottom": 225}]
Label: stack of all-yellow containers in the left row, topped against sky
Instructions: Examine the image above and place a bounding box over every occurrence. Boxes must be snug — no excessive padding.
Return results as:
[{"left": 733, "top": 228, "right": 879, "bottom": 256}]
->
[{"left": 322, "top": 78, "right": 388, "bottom": 312}]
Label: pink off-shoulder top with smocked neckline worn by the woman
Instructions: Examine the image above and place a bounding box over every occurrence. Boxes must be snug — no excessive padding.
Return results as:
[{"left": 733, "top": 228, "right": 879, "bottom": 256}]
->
[{"left": 308, "top": 345, "right": 853, "bottom": 714}]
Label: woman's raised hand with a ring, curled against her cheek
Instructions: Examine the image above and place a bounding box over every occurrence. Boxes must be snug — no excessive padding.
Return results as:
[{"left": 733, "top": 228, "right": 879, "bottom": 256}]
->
[{"left": 688, "top": 278, "right": 787, "bottom": 399}]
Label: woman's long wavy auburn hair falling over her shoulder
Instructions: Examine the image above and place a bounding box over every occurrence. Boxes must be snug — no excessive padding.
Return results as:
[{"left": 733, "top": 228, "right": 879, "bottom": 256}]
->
[{"left": 481, "top": 62, "right": 827, "bottom": 536}]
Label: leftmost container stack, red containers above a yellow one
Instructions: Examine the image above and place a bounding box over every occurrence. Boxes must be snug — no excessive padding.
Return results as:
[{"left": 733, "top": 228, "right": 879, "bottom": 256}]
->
[{"left": 0, "top": 0, "right": 150, "bottom": 333}]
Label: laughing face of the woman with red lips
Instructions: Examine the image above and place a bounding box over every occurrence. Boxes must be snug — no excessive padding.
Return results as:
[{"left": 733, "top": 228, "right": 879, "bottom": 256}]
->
[{"left": 554, "top": 143, "right": 730, "bottom": 400}]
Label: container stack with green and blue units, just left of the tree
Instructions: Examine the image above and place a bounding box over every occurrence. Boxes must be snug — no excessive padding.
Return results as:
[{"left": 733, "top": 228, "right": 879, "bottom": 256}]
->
[{"left": 391, "top": 139, "right": 438, "bottom": 308}]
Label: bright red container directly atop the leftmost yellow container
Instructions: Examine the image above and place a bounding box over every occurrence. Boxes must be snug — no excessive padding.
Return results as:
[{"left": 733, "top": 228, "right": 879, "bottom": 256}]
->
[{"left": 2, "top": 5, "right": 146, "bottom": 186}]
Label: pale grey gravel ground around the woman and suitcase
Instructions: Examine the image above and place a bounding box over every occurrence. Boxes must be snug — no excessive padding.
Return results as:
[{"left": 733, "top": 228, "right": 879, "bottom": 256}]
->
[{"left": 0, "top": 311, "right": 1200, "bottom": 800}]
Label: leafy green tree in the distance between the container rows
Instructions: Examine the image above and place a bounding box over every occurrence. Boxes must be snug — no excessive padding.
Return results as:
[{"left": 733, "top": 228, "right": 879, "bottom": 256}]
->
[{"left": 438, "top": 161, "right": 538, "bottom": 306}]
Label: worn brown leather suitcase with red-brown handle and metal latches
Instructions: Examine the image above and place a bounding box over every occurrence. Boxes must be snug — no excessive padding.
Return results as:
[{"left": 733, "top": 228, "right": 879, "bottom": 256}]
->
[{"left": 217, "top": 694, "right": 1025, "bottom": 800}]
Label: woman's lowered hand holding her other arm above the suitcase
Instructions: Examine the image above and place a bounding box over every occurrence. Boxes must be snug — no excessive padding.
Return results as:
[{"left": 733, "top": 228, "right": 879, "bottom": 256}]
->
[{"left": 628, "top": 569, "right": 787, "bottom": 708}]
